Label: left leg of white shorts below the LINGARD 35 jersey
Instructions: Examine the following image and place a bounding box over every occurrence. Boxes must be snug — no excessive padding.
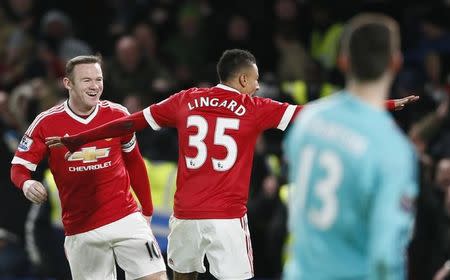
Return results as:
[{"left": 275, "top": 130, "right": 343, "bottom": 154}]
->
[{"left": 167, "top": 216, "right": 208, "bottom": 273}]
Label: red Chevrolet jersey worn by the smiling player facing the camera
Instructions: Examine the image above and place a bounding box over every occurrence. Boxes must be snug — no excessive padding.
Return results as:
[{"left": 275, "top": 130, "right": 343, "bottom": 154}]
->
[{"left": 12, "top": 101, "right": 138, "bottom": 235}]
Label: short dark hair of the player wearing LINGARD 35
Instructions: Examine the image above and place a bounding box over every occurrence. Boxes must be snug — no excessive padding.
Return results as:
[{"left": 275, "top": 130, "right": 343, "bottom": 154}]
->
[{"left": 217, "top": 49, "right": 256, "bottom": 82}]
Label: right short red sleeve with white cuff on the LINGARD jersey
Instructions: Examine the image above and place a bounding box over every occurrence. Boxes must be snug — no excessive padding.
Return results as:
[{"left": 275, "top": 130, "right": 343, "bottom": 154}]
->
[{"left": 254, "top": 97, "right": 301, "bottom": 131}]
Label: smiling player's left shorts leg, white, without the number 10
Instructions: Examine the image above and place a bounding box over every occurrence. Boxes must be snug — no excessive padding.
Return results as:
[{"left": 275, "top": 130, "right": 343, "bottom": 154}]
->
[{"left": 64, "top": 230, "right": 116, "bottom": 280}]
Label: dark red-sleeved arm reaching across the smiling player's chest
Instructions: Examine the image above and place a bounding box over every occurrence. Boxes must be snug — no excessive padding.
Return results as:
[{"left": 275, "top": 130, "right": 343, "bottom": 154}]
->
[{"left": 45, "top": 111, "right": 148, "bottom": 152}]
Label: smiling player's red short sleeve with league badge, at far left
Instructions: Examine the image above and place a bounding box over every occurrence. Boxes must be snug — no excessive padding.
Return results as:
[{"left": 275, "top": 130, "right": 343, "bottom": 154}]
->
[{"left": 11, "top": 118, "right": 47, "bottom": 171}]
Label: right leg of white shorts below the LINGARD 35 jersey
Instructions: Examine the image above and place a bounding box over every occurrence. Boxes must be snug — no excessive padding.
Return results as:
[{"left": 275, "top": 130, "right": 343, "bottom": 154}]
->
[{"left": 206, "top": 216, "right": 253, "bottom": 279}]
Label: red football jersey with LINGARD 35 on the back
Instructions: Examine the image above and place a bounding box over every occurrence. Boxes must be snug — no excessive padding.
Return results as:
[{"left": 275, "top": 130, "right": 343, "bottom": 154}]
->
[{"left": 144, "top": 84, "right": 299, "bottom": 219}]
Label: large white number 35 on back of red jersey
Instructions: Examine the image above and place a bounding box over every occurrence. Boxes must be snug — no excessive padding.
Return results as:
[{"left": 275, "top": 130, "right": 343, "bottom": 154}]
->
[{"left": 185, "top": 115, "right": 239, "bottom": 171}]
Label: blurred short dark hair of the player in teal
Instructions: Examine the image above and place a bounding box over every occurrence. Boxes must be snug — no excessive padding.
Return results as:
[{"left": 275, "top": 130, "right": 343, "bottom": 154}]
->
[{"left": 341, "top": 13, "right": 400, "bottom": 82}]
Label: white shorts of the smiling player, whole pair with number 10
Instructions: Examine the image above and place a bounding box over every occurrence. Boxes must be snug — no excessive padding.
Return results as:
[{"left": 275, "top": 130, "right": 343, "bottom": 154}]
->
[{"left": 64, "top": 213, "right": 166, "bottom": 280}]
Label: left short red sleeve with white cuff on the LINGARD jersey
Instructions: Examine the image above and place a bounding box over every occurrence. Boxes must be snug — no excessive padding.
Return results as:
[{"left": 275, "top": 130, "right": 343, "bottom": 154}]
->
[{"left": 143, "top": 91, "right": 183, "bottom": 130}]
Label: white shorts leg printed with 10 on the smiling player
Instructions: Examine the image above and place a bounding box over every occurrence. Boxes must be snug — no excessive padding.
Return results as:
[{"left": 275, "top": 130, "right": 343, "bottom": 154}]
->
[{"left": 104, "top": 213, "right": 166, "bottom": 279}]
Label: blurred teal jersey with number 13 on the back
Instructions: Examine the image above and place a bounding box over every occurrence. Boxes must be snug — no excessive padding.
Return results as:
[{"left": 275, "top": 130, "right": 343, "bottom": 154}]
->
[{"left": 284, "top": 92, "right": 418, "bottom": 280}]
